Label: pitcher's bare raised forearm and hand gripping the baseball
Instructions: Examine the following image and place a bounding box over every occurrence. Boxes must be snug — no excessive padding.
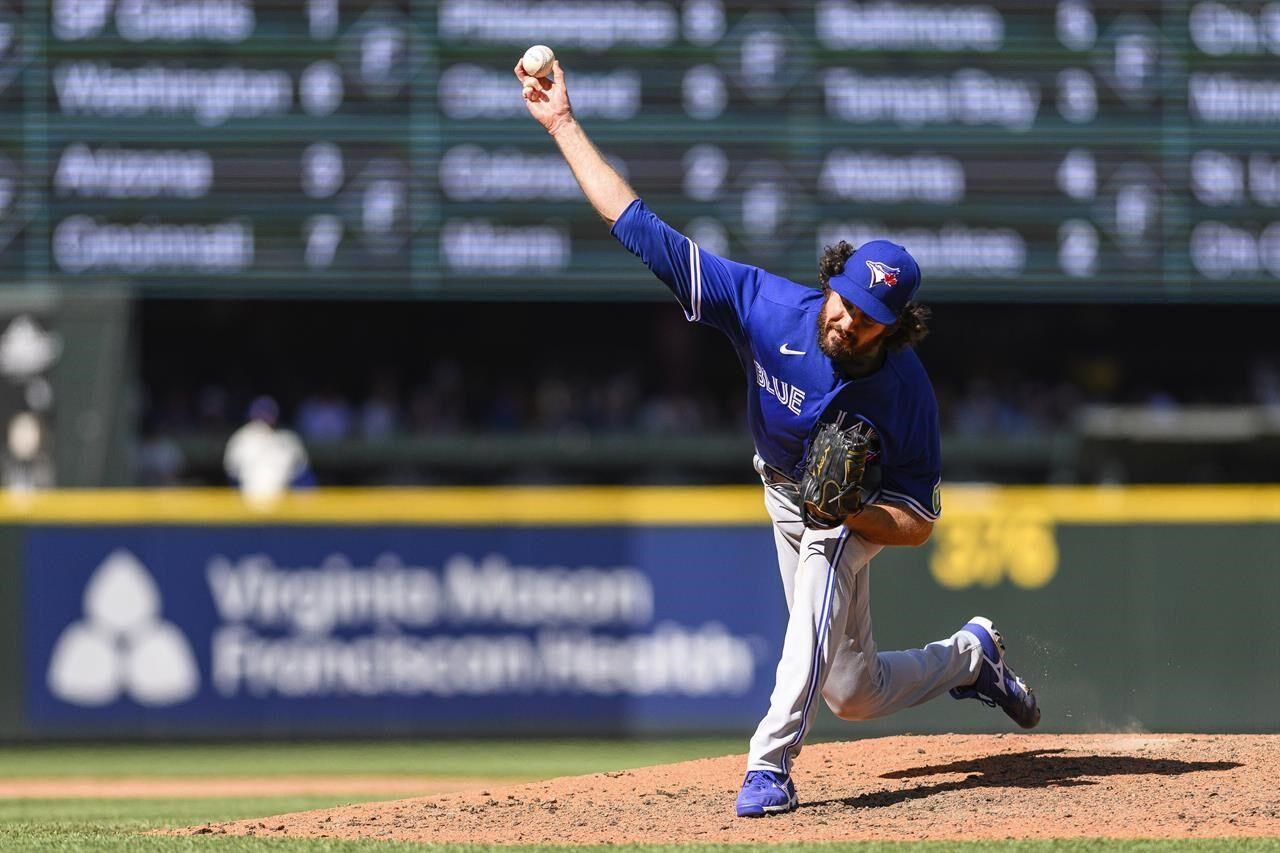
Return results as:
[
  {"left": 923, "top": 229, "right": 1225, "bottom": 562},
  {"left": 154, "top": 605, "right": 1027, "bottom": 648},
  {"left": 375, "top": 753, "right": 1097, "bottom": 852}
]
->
[{"left": 516, "top": 60, "right": 639, "bottom": 225}]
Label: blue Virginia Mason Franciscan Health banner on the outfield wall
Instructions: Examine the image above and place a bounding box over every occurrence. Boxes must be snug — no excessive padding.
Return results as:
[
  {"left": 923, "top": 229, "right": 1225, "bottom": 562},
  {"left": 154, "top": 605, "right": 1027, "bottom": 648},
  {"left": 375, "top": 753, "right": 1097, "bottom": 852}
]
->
[{"left": 23, "top": 525, "right": 786, "bottom": 735}]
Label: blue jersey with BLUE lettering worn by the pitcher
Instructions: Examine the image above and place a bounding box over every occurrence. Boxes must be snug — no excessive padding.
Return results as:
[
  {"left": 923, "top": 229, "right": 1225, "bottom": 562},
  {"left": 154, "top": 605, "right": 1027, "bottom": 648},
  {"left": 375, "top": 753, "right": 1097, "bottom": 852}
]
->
[{"left": 613, "top": 199, "right": 942, "bottom": 520}]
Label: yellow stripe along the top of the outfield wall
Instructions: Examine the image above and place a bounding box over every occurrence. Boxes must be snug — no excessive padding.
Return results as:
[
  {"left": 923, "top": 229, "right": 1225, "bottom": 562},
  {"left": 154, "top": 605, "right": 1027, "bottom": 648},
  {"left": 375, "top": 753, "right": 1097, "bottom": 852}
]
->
[{"left": 0, "top": 485, "right": 1280, "bottom": 526}]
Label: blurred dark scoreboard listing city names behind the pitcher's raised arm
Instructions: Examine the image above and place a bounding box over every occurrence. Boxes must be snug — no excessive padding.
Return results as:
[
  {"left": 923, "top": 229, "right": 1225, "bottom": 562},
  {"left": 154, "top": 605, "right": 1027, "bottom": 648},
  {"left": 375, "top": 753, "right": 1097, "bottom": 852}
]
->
[{"left": 0, "top": 0, "right": 1280, "bottom": 298}]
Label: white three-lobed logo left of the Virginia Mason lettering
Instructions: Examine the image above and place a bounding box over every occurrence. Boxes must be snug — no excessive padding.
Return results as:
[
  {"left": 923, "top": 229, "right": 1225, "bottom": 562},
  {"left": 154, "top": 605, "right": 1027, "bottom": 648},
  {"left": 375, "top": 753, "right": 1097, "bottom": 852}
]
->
[{"left": 49, "top": 548, "right": 200, "bottom": 706}]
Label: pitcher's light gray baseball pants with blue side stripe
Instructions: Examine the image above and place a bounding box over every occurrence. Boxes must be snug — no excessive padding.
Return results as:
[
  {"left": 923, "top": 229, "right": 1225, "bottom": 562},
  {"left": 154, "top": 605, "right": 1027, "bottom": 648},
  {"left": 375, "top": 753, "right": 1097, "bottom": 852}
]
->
[{"left": 746, "top": 461, "right": 982, "bottom": 774}]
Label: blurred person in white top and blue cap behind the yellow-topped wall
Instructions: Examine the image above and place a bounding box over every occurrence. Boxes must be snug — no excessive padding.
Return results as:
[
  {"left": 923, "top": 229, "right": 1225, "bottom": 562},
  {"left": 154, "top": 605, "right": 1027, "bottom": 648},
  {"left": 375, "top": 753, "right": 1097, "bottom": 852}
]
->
[{"left": 223, "top": 397, "right": 315, "bottom": 503}]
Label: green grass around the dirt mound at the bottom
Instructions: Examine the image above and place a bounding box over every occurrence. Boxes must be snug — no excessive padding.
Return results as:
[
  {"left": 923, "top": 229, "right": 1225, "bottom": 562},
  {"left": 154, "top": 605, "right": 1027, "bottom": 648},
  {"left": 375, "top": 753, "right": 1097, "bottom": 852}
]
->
[{"left": 0, "top": 739, "right": 1280, "bottom": 853}]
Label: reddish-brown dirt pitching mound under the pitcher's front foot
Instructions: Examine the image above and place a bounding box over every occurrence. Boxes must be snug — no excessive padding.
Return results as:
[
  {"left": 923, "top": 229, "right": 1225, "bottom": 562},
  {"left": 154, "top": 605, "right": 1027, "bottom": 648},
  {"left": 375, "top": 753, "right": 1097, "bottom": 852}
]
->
[{"left": 180, "top": 735, "right": 1280, "bottom": 844}]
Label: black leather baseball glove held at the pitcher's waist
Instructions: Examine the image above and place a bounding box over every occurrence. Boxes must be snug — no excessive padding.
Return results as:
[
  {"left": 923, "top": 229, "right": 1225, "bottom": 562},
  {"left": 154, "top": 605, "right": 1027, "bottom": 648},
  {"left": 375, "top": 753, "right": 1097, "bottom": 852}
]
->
[{"left": 800, "top": 415, "right": 873, "bottom": 530}]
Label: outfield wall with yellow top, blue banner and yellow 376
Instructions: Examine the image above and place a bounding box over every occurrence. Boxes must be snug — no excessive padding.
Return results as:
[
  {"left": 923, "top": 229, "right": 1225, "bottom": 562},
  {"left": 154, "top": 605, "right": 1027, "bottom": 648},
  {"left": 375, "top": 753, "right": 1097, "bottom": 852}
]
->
[{"left": 0, "top": 485, "right": 1280, "bottom": 739}]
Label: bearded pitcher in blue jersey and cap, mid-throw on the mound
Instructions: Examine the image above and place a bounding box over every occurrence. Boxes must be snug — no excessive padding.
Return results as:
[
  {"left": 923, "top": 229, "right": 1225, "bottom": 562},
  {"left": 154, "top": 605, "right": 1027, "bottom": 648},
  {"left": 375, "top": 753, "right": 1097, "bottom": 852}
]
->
[{"left": 516, "top": 61, "right": 1039, "bottom": 817}]
